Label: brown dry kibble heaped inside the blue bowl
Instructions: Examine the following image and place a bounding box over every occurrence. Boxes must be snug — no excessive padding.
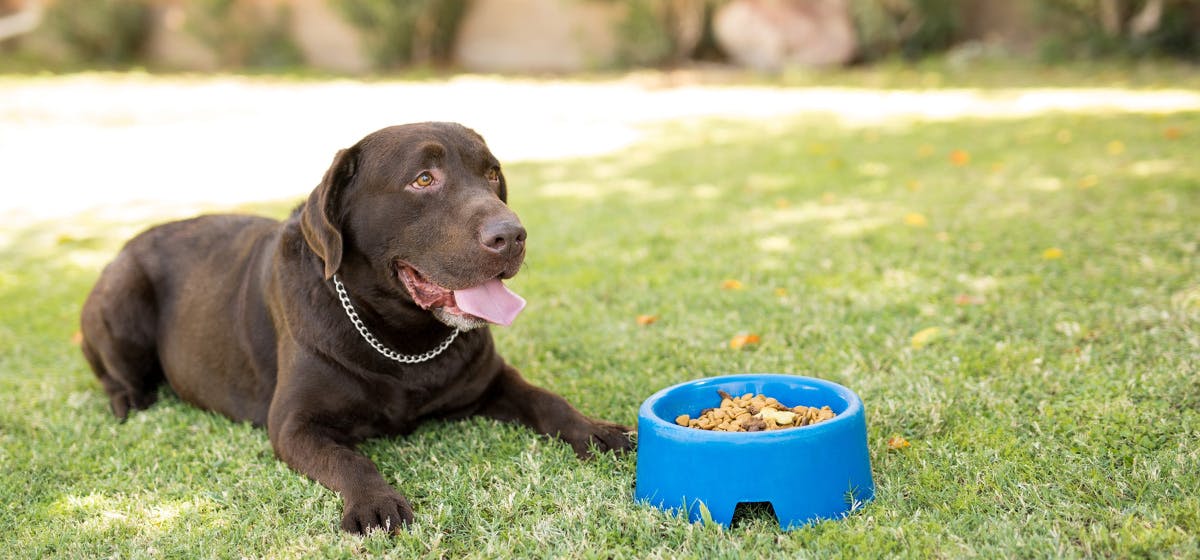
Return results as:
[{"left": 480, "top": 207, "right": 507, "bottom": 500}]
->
[{"left": 676, "top": 390, "right": 836, "bottom": 432}]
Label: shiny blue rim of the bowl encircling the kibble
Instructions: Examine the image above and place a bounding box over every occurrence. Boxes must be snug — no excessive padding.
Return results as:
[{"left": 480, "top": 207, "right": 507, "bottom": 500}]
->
[{"left": 637, "top": 373, "right": 863, "bottom": 439}]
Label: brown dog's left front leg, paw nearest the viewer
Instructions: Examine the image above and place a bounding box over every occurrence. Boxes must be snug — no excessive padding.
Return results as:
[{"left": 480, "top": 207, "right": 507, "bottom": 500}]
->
[{"left": 268, "top": 407, "right": 413, "bottom": 532}]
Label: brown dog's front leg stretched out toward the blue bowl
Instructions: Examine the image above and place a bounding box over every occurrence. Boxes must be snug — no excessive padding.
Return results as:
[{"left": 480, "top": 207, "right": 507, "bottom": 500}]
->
[{"left": 480, "top": 365, "right": 632, "bottom": 458}]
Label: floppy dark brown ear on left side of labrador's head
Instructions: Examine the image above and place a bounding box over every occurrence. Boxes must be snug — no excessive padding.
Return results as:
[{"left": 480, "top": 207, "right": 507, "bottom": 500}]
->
[{"left": 300, "top": 146, "right": 359, "bottom": 279}]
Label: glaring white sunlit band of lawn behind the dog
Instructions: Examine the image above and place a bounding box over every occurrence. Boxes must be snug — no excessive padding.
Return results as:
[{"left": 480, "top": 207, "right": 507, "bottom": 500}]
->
[{"left": 9, "top": 76, "right": 1200, "bottom": 218}]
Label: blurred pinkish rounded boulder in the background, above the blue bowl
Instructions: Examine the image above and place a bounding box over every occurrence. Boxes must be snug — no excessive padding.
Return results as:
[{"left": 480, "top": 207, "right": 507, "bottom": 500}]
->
[{"left": 713, "top": 0, "right": 858, "bottom": 71}]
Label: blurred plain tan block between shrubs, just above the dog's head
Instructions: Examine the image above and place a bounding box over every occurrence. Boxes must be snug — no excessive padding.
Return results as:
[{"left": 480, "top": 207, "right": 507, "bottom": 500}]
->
[{"left": 454, "top": 0, "right": 623, "bottom": 72}]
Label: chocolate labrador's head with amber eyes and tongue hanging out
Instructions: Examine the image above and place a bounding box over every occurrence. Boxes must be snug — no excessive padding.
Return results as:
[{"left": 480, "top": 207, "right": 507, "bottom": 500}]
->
[{"left": 300, "top": 122, "right": 526, "bottom": 329}]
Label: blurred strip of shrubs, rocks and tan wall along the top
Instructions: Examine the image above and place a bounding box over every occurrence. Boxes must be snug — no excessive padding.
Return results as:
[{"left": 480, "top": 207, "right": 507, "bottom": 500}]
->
[{"left": 0, "top": 0, "right": 1200, "bottom": 74}]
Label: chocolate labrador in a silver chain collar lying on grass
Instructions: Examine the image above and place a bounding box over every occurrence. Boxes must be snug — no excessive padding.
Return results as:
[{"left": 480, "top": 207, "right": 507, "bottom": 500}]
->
[{"left": 82, "top": 122, "right": 630, "bottom": 532}]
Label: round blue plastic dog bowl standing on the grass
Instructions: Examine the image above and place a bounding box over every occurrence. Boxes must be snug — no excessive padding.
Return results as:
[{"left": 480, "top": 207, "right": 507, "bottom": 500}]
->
[{"left": 634, "top": 374, "right": 875, "bottom": 530}]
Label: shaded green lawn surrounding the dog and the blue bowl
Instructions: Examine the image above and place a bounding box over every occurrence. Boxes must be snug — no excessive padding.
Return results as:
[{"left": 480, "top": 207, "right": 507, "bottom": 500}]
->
[{"left": 0, "top": 76, "right": 1200, "bottom": 558}]
